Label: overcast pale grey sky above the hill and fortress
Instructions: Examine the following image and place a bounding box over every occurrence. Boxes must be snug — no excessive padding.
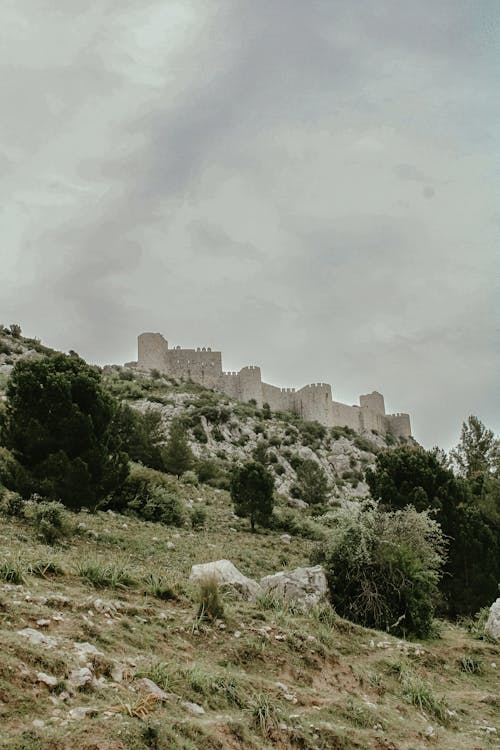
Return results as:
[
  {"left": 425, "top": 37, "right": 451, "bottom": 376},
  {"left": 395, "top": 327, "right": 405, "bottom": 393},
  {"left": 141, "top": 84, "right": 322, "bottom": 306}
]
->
[{"left": 0, "top": 0, "right": 500, "bottom": 448}]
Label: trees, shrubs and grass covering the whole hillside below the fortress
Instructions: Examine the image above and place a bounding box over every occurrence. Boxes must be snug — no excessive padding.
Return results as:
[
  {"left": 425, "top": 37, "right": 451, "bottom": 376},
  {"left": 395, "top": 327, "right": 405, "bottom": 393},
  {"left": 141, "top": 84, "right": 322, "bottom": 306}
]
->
[{"left": 0, "top": 328, "right": 500, "bottom": 750}]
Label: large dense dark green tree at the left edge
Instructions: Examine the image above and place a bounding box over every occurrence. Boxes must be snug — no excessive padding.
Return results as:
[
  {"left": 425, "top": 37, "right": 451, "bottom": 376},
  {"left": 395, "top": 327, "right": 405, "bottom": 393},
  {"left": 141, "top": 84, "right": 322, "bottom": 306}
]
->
[{"left": 3, "top": 354, "right": 128, "bottom": 508}]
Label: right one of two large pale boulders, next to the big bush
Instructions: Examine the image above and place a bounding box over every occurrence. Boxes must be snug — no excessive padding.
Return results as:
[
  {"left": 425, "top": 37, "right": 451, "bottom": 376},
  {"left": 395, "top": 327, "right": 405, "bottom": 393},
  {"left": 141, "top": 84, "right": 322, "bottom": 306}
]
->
[{"left": 260, "top": 565, "right": 328, "bottom": 609}]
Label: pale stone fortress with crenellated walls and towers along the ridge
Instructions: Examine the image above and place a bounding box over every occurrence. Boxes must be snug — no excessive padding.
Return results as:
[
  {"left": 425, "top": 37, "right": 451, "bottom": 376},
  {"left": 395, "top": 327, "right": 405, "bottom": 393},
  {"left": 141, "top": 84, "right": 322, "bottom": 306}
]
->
[{"left": 137, "top": 333, "right": 411, "bottom": 437}]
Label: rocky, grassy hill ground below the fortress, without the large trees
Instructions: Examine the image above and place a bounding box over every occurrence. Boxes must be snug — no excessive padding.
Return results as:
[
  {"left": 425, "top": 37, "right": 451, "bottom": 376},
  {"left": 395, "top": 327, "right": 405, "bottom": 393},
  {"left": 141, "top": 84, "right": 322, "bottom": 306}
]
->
[{"left": 0, "top": 328, "right": 499, "bottom": 750}]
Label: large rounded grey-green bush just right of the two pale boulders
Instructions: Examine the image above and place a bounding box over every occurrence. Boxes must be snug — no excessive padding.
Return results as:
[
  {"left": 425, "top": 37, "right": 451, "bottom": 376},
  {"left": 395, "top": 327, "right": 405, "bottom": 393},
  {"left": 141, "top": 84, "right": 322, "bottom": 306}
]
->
[{"left": 316, "top": 504, "right": 445, "bottom": 637}]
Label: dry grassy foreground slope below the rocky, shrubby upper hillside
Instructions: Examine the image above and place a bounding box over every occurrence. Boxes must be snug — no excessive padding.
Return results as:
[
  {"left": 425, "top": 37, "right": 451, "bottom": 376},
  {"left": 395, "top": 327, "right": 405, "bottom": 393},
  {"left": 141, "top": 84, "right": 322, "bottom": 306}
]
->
[{"left": 0, "top": 485, "right": 500, "bottom": 750}]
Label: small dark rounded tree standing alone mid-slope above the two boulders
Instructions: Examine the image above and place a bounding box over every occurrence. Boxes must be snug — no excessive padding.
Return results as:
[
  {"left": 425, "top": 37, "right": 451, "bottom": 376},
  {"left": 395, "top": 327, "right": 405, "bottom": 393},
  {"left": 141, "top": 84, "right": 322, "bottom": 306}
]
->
[{"left": 230, "top": 461, "right": 274, "bottom": 531}]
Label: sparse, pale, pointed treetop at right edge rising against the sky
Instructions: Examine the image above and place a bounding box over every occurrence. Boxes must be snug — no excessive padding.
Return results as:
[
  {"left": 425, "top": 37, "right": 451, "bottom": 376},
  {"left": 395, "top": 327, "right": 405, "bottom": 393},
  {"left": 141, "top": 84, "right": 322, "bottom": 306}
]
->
[{"left": 450, "top": 415, "right": 500, "bottom": 479}]
